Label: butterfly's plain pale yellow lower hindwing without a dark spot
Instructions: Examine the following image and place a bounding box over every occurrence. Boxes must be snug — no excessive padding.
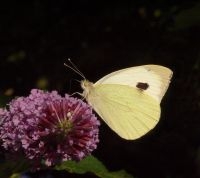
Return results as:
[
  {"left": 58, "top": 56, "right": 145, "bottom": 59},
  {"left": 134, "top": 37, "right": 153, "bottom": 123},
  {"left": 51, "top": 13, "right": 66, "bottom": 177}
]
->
[{"left": 87, "top": 84, "right": 160, "bottom": 140}]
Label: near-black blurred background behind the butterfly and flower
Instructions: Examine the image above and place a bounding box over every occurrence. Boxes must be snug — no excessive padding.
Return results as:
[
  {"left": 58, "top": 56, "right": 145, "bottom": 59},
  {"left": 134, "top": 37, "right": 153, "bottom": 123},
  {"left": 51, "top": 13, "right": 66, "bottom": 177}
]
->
[{"left": 0, "top": 0, "right": 200, "bottom": 178}]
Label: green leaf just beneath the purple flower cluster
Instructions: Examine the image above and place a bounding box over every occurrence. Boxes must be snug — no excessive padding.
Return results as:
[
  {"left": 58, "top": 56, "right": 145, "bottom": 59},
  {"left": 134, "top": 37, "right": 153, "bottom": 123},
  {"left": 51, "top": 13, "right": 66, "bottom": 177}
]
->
[{"left": 56, "top": 156, "right": 133, "bottom": 178}]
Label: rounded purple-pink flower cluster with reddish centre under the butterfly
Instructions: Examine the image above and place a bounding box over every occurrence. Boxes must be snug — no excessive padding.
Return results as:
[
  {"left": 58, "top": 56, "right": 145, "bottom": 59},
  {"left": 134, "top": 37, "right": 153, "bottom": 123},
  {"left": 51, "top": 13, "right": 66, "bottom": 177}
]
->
[{"left": 0, "top": 89, "right": 100, "bottom": 166}]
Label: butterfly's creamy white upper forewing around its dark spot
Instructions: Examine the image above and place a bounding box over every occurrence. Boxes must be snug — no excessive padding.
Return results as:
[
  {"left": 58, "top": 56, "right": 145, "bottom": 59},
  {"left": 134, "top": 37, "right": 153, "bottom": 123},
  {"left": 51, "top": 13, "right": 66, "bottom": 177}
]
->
[{"left": 94, "top": 65, "right": 172, "bottom": 103}]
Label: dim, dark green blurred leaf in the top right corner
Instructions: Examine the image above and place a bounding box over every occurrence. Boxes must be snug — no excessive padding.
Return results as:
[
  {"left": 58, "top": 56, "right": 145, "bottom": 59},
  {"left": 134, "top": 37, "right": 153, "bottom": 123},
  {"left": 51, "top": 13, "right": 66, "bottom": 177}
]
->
[{"left": 174, "top": 3, "right": 200, "bottom": 30}]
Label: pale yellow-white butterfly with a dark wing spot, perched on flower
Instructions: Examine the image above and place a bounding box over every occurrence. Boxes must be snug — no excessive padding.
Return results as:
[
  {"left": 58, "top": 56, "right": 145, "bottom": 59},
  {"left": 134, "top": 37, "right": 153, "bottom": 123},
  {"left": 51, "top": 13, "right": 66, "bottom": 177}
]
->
[{"left": 65, "top": 60, "right": 173, "bottom": 140}]
